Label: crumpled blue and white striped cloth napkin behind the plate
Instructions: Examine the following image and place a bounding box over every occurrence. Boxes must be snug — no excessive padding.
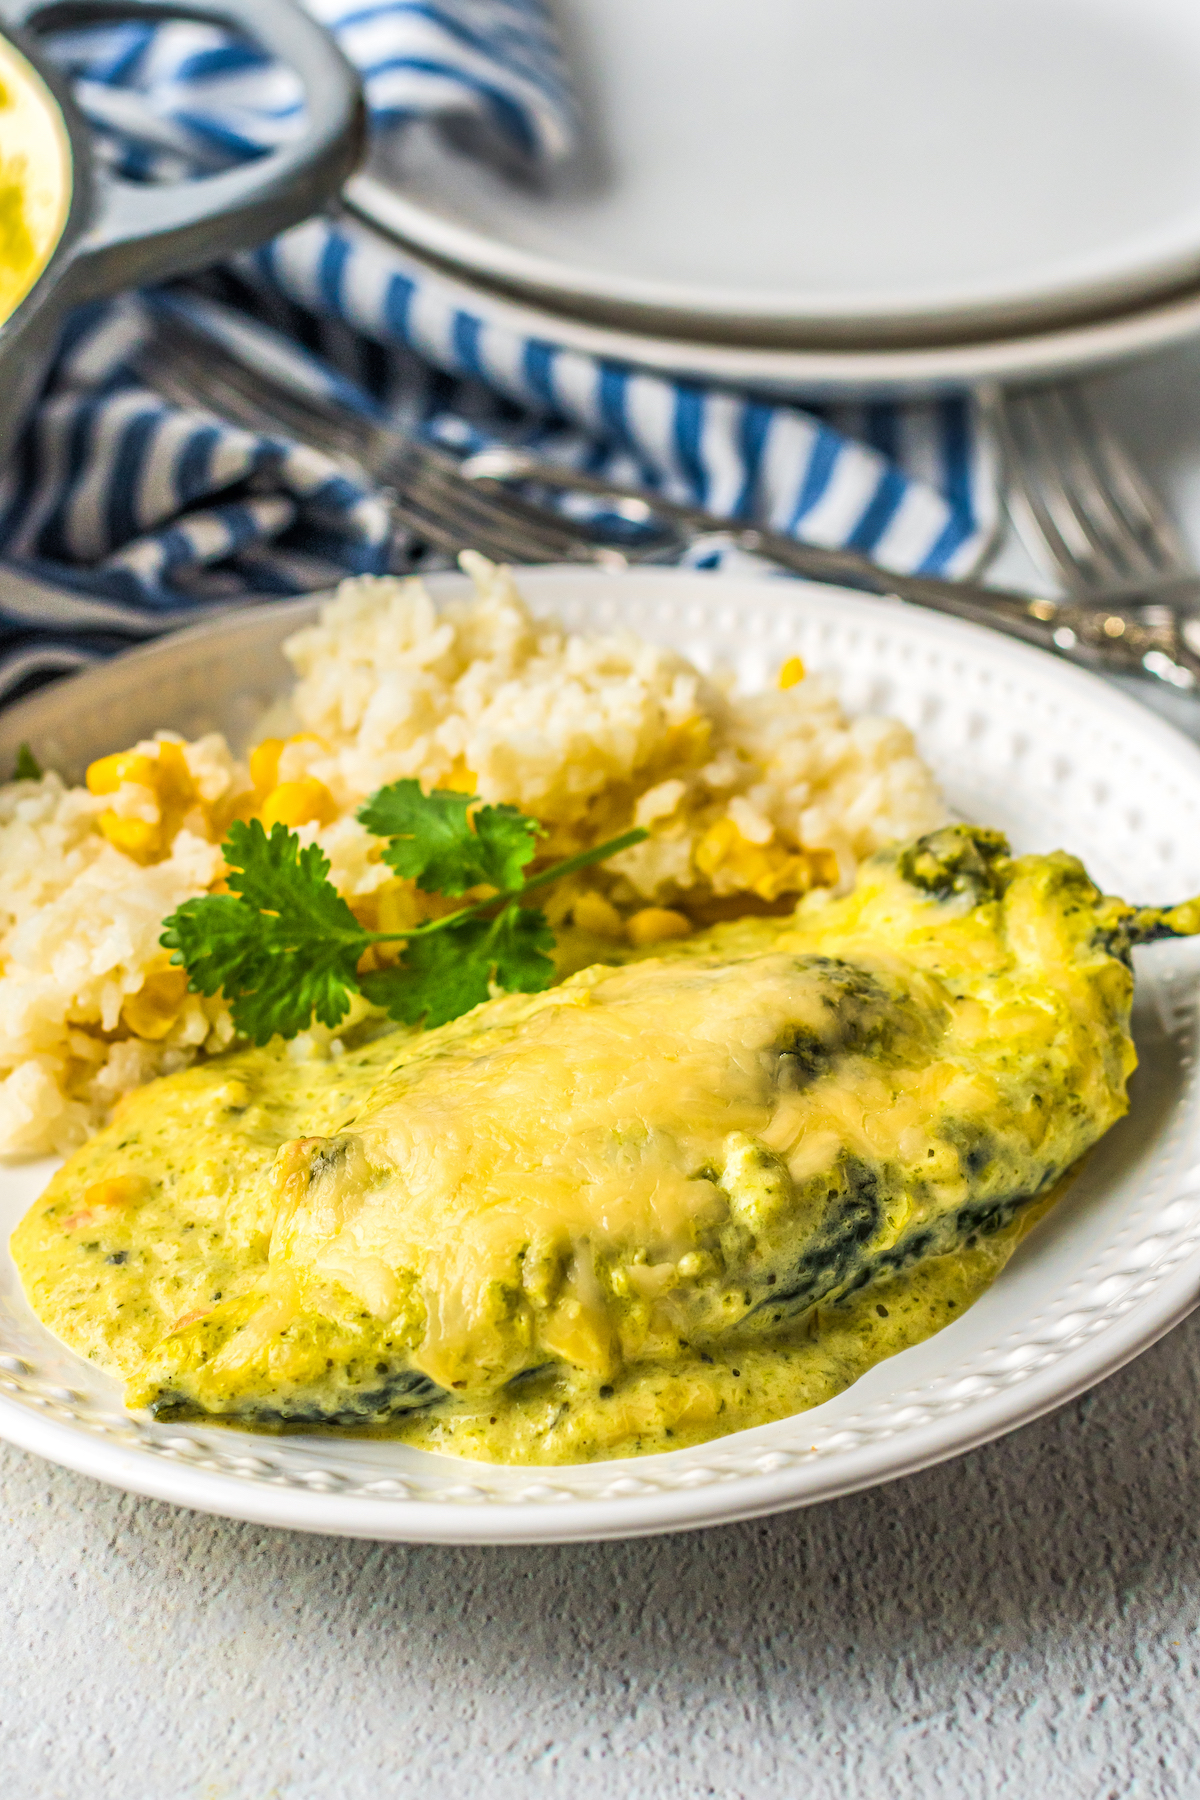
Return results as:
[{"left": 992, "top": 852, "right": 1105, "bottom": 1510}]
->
[{"left": 0, "top": 0, "right": 997, "bottom": 700}]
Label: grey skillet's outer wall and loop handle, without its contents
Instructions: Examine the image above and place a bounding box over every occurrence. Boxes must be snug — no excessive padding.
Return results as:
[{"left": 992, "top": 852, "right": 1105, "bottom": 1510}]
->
[{"left": 0, "top": 0, "right": 363, "bottom": 464}]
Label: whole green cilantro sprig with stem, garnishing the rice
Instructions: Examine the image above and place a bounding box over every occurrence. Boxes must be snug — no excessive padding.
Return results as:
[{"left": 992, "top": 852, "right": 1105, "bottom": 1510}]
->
[{"left": 158, "top": 781, "right": 646, "bottom": 1044}]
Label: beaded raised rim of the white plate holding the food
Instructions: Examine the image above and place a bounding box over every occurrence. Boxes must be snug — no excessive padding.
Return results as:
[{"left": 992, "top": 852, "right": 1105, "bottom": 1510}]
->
[{"left": 0, "top": 569, "right": 1200, "bottom": 1543}]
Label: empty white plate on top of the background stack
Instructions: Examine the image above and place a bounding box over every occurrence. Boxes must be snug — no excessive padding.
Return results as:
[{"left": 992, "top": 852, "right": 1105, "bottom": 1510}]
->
[{"left": 349, "top": 0, "right": 1200, "bottom": 347}]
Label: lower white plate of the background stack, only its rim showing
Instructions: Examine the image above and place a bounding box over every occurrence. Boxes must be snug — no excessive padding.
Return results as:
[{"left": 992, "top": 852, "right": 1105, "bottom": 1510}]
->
[{"left": 344, "top": 208, "right": 1200, "bottom": 401}]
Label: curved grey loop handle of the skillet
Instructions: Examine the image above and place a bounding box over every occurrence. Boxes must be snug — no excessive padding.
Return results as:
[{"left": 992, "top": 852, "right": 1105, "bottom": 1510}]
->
[{"left": 0, "top": 0, "right": 365, "bottom": 301}]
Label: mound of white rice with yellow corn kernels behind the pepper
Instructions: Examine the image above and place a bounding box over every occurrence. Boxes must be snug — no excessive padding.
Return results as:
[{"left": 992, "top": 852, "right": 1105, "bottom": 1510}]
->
[{"left": 0, "top": 558, "right": 945, "bottom": 1156}]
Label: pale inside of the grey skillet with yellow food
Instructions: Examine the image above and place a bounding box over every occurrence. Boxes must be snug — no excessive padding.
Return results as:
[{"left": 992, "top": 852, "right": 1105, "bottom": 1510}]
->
[{"left": 0, "top": 38, "right": 72, "bottom": 324}]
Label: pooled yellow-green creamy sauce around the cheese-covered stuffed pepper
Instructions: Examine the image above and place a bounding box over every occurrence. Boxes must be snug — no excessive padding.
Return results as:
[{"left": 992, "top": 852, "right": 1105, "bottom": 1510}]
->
[{"left": 14, "top": 1030, "right": 1043, "bottom": 1463}]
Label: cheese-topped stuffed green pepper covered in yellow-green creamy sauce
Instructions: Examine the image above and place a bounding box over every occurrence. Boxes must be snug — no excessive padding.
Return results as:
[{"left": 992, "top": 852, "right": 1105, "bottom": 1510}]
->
[{"left": 13, "top": 832, "right": 1165, "bottom": 1463}]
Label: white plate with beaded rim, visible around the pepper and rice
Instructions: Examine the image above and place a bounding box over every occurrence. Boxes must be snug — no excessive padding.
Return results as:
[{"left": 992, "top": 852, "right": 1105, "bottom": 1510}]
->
[{"left": 0, "top": 569, "right": 1200, "bottom": 1543}]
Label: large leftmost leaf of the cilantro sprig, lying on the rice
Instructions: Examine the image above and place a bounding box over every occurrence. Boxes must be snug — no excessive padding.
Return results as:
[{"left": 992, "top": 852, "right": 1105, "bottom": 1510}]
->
[{"left": 158, "top": 819, "right": 371, "bottom": 1044}]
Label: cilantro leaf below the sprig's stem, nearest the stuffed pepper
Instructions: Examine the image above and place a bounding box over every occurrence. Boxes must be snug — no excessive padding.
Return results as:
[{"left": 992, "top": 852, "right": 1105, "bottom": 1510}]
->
[{"left": 360, "top": 904, "right": 554, "bottom": 1026}]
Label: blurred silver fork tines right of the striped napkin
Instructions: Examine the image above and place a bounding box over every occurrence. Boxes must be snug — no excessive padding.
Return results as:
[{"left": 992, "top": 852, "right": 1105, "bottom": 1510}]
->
[{"left": 991, "top": 382, "right": 1200, "bottom": 605}]
